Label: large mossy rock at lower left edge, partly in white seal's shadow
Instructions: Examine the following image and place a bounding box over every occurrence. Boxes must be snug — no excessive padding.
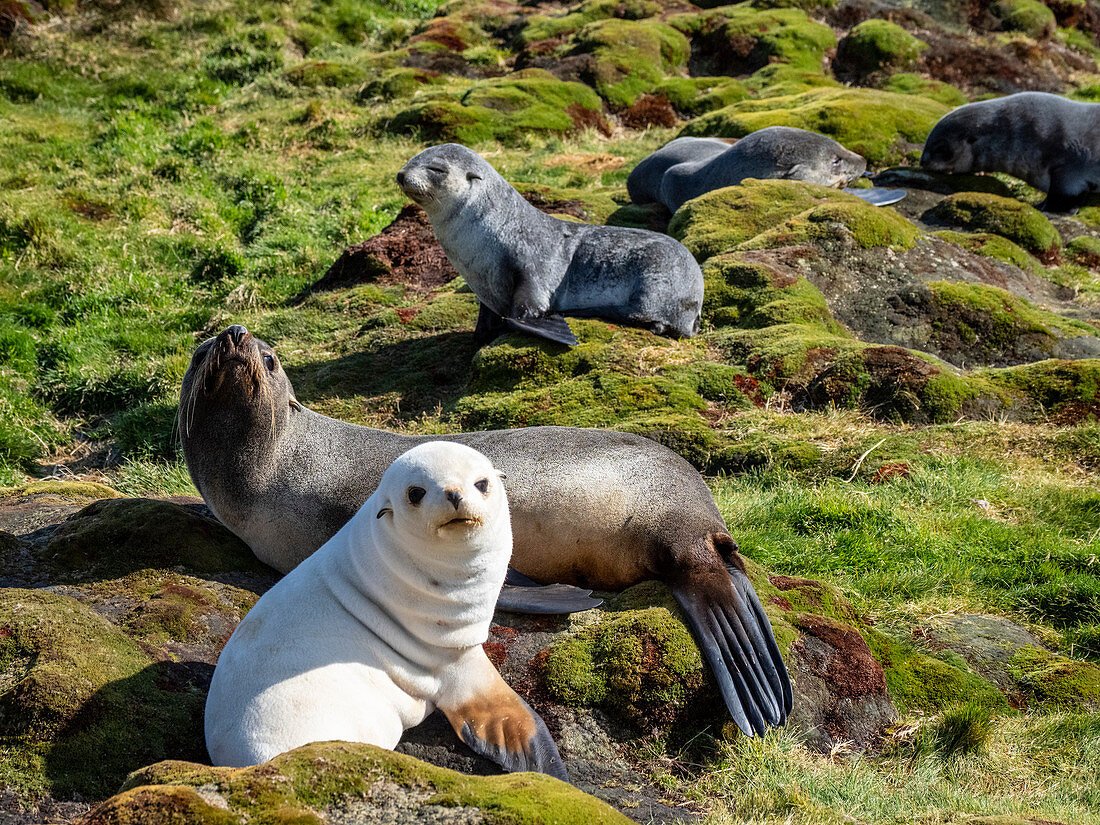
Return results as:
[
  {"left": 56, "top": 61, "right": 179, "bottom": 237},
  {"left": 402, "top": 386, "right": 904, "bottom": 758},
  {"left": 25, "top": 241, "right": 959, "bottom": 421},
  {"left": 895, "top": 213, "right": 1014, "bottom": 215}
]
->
[{"left": 0, "top": 589, "right": 206, "bottom": 799}]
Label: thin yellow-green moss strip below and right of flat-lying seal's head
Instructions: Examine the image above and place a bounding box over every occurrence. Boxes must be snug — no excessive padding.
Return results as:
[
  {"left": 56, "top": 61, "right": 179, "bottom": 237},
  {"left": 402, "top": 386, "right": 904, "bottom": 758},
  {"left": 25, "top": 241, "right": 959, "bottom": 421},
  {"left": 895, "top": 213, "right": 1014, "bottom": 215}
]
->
[{"left": 740, "top": 196, "right": 921, "bottom": 250}]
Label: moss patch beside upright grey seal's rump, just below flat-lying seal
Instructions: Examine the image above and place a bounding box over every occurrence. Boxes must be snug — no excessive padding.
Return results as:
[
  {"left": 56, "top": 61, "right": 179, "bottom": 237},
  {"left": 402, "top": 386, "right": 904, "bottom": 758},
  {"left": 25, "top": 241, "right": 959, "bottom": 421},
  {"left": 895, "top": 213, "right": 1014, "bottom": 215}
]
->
[{"left": 669, "top": 178, "right": 859, "bottom": 262}]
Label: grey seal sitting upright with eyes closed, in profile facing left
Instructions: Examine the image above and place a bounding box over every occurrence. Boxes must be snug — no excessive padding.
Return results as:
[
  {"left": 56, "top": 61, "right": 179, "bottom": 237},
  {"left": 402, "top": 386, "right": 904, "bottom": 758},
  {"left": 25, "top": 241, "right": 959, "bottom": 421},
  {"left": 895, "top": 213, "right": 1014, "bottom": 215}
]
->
[{"left": 397, "top": 143, "right": 703, "bottom": 344}]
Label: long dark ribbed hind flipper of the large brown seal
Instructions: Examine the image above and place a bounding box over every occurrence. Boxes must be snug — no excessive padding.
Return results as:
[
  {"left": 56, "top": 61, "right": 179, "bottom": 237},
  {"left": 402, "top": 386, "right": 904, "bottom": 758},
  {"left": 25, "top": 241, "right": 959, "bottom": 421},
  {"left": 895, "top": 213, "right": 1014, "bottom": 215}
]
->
[{"left": 672, "top": 563, "right": 793, "bottom": 736}]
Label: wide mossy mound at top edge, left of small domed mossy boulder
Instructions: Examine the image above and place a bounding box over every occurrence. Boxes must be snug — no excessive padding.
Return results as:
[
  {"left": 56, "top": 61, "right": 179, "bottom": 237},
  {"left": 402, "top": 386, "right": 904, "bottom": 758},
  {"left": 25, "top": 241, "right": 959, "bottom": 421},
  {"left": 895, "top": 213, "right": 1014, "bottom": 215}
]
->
[{"left": 669, "top": 3, "right": 836, "bottom": 76}]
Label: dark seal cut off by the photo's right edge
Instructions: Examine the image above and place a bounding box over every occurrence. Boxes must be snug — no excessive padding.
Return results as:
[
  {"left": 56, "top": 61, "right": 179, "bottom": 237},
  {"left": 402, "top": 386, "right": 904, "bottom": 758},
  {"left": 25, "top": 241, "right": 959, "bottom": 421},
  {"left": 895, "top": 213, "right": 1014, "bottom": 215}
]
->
[{"left": 921, "top": 91, "right": 1100, "bottom": 212}]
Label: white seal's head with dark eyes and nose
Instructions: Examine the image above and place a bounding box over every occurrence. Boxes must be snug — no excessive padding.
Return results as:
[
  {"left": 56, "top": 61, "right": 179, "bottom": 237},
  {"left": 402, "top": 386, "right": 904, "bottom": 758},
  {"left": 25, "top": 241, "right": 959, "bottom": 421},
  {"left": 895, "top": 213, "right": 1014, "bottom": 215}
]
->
[{"left": 376, "top": 441, "right": 510, "bottom": 550}]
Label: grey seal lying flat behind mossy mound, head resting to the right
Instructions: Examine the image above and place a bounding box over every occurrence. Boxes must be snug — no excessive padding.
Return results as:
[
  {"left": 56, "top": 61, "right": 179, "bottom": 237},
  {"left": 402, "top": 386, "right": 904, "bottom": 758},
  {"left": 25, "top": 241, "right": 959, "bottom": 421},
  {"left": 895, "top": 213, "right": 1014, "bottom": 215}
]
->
[{"left": 627, "top": 127, "right": 867, "bottom": 212}]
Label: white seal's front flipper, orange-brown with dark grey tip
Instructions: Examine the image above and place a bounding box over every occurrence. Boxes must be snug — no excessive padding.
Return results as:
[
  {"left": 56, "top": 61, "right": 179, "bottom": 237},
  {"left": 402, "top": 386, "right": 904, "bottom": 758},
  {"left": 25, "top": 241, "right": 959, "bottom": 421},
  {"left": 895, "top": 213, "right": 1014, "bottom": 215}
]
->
[{"left": 437, "top": 660, "right": 569, "bottom": 782}]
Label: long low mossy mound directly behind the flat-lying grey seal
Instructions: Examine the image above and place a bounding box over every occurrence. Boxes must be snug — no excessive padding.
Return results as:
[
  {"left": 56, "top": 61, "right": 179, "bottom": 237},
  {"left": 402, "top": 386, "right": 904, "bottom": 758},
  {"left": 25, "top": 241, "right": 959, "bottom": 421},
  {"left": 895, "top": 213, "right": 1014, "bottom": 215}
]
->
[{"left": 680, "top": 88, "right": 949, "bottom": 164}]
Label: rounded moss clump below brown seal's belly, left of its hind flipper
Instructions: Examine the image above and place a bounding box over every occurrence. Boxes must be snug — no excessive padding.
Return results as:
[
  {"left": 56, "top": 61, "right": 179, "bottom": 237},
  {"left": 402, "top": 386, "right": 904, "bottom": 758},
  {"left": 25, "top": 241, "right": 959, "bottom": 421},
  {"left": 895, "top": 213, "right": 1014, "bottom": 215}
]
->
[{"left": 540, "top": 607, "right": 714, "bottom": 729}]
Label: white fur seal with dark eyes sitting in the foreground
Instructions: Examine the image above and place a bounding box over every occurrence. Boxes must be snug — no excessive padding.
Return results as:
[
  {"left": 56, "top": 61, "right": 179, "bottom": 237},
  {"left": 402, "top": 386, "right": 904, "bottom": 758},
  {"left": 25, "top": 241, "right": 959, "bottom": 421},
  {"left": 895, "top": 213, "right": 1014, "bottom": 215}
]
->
[{"left": 205, "top": 441, "right": 567, "bottom": 779}]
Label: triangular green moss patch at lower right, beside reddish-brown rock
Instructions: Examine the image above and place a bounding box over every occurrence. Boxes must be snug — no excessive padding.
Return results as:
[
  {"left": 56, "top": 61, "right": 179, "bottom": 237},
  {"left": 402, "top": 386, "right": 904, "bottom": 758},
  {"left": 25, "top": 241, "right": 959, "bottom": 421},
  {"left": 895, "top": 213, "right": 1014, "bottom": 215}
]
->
[{"left": 864, "top": 628, "right": 1010, "bottom": 712}]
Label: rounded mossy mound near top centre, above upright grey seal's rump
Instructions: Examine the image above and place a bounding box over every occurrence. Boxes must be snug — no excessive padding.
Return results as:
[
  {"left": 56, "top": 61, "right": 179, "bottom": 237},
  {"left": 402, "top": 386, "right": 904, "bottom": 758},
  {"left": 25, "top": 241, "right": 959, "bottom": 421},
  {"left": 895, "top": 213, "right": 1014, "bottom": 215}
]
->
[{"left": 571, "top": 20, "right": 690, "bottom": 107}]
